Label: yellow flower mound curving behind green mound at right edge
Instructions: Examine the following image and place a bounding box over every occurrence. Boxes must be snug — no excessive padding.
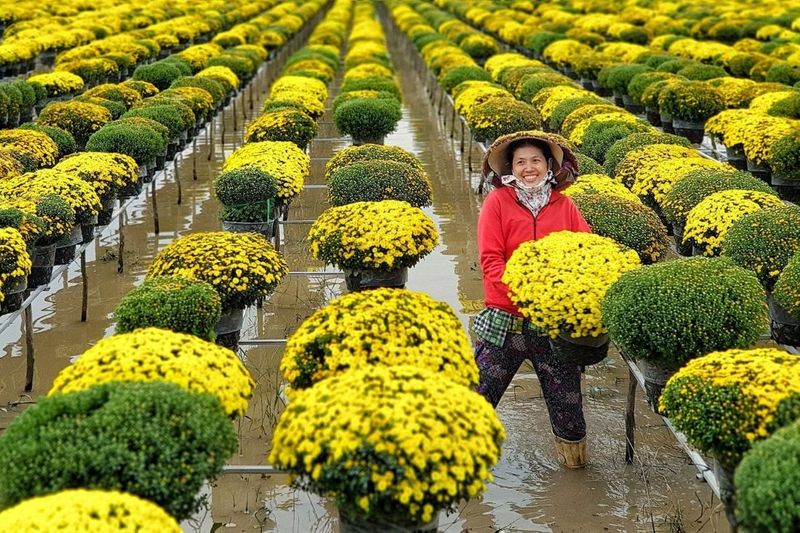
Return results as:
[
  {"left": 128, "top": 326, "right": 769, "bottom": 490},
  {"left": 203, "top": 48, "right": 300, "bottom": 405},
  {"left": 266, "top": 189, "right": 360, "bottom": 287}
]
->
[{"left": 683, "top": 190, "right": 783, "bottom": 256}]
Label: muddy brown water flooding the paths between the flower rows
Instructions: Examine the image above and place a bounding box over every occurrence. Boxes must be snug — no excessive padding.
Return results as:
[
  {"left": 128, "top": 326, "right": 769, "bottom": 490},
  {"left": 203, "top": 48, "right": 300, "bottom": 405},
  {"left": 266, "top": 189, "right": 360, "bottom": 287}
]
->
[{"left": 0, "top": 28, "right": 727, "bottom": 532}]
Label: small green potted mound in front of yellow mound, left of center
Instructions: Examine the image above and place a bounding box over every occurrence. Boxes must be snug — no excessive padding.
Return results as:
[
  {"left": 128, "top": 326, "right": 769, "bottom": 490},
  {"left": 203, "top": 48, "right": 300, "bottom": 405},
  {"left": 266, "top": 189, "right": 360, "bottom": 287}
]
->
[{"left": 214, "top": 166, "right": 278, "bottom": 222}]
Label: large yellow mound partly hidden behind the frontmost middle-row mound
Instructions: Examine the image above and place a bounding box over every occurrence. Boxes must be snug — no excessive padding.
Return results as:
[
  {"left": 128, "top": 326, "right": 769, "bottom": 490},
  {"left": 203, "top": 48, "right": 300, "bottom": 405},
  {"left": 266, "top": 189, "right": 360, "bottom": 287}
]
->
[{"left": 280, "top": 288, "right": 478, "bottom": 389}]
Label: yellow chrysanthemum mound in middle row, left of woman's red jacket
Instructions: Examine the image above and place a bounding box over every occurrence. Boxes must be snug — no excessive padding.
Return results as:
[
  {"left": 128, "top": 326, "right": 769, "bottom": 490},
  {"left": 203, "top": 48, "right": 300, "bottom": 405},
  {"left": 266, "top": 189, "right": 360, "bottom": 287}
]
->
[{"left": 306, "top": 200, "right": 439, "bottom": 270}]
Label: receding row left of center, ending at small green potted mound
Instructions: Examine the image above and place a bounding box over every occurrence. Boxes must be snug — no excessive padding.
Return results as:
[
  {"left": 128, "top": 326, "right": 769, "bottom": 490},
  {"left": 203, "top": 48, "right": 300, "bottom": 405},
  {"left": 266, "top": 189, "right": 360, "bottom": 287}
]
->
[{"left": 214, "top": 0, "right": 352, "bottom": 238}]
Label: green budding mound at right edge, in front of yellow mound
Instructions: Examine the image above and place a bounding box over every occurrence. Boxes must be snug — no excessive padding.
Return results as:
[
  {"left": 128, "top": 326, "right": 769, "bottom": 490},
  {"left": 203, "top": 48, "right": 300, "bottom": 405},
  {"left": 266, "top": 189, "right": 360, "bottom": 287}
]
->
[{"left": 722, "top": 205, "right": 800, "bottom": 291}]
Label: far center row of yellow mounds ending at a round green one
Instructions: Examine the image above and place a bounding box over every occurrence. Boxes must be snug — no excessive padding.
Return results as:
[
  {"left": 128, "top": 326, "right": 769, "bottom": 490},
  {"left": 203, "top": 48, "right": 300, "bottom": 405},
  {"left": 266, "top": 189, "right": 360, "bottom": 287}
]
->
[{"left": 331, "top": 0, "right": 402, "bottom": 145}]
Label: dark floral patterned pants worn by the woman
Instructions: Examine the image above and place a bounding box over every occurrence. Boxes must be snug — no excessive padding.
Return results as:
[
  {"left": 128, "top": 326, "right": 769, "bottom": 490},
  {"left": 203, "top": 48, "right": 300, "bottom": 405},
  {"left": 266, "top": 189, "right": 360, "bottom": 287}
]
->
[{"left": 475, "top": 331, "right": 586, "bottom": 441}]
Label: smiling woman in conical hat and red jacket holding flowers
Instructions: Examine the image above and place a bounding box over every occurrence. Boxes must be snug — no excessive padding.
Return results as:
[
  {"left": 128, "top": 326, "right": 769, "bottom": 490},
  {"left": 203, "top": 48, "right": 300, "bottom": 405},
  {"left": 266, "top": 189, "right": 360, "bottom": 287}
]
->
[{"left": 474, "top": 131, "right": 591, "bottom": 468}]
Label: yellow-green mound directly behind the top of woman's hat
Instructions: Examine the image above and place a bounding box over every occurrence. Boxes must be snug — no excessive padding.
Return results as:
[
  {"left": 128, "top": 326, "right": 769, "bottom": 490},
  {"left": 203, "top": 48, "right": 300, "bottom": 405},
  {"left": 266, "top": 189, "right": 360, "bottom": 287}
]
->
[{"left": 467, "top": 98, "right": 542, "bottom": 142}]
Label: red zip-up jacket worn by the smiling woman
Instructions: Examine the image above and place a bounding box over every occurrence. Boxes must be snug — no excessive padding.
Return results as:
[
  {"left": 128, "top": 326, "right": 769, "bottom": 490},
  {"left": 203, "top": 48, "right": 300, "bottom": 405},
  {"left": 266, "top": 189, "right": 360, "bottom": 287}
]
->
[{"left": 478, "top": 186, "right": 592, "bottom": 316}]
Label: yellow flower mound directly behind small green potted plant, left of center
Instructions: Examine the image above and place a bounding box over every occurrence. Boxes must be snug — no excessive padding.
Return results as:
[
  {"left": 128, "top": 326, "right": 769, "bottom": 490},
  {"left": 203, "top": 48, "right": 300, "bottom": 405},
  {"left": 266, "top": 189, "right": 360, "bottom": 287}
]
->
[{"left": 222, "top": 141, "right": 311, "bottom": 202}]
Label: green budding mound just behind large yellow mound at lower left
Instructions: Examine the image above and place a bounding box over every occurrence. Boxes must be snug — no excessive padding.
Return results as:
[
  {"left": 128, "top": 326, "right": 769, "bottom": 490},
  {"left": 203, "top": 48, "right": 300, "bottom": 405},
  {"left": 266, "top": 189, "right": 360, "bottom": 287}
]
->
[{"left": 114, "top": 276, "right": 222, "bottom": 341}]
